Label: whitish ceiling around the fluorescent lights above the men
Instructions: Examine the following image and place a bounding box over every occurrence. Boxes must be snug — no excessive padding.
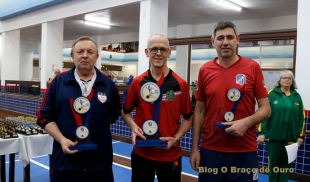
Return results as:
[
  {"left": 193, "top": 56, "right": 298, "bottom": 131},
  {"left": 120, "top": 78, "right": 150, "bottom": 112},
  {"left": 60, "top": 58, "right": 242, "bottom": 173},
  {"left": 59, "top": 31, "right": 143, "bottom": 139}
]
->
[{"left": 21, "top": 0, "right": 298, "bottom": 42}]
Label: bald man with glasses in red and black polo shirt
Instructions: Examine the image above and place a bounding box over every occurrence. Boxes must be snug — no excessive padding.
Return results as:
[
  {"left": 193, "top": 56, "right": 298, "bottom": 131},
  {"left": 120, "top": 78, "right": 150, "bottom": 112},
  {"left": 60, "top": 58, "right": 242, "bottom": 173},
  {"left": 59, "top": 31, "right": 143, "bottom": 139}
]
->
[{"left": 122, "top": 35, "right": 192, "bottom": 182}]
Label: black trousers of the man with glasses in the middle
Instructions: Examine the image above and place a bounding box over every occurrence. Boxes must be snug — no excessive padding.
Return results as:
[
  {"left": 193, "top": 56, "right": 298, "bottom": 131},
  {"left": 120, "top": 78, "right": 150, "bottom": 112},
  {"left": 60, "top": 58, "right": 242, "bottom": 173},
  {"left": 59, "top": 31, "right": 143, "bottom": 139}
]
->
[{"left": 131, "top": 152, "right": 182, "bottom": 182}]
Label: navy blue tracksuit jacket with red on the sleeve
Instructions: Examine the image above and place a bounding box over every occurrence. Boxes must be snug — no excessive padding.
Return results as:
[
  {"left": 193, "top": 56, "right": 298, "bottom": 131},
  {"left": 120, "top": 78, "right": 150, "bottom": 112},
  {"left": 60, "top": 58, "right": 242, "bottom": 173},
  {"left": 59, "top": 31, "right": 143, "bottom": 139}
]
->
[{"left": 37, "top": 66, "right": 121, "bottom": 171}]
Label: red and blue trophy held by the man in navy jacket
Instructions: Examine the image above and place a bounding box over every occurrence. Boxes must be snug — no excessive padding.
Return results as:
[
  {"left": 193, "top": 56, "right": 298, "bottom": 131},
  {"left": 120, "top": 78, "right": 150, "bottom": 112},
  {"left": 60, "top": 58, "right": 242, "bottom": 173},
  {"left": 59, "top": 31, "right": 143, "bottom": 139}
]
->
[{"left": 69, "top": 90, "right": 97, "bottom": 150}]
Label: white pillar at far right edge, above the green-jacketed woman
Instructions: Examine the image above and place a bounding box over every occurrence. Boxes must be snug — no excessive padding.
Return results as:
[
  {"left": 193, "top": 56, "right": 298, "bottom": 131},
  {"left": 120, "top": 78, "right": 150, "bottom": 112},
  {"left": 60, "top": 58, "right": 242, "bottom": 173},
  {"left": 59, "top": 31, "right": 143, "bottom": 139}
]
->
[{"left": 295, "top": 0, "right": 310, "bottom": 110}]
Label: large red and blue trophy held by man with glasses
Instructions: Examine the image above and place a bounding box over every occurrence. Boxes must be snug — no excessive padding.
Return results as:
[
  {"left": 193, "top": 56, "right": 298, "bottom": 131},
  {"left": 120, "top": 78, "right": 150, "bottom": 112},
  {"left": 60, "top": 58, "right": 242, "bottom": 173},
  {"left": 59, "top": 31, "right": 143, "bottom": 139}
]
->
[{"left": 135, "top": 73, "right": 167, "bottom": 147}]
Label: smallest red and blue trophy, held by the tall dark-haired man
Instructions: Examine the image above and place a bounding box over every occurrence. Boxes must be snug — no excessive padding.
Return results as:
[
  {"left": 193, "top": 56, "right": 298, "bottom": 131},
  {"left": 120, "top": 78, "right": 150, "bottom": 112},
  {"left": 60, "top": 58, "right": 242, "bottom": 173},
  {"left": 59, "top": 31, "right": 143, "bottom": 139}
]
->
[{"left": 216, "top": 84, "right": 245, "bottom": 129}]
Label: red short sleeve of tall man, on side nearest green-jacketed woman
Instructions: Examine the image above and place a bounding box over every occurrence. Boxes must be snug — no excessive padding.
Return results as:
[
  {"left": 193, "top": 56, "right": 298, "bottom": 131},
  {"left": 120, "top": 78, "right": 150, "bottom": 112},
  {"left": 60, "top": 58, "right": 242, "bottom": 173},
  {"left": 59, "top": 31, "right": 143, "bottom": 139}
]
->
[{"left": 254, "top": 63, "right": 268, "bottom": 100}]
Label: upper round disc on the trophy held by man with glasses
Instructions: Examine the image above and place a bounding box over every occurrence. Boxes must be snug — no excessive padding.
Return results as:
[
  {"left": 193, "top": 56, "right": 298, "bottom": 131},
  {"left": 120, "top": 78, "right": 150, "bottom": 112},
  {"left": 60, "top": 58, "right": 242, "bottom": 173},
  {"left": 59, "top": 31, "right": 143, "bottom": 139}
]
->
[{"left": 140, "top": 82, "right": 160, "bottom": 103}]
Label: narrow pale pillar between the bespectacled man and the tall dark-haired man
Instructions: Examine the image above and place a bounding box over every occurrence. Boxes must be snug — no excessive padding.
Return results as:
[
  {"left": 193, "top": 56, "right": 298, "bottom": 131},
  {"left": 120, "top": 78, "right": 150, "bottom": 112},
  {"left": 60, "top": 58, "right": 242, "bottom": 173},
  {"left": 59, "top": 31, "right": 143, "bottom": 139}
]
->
[{"left": 175, "top": 25, "right": 192, "bottom": 81}]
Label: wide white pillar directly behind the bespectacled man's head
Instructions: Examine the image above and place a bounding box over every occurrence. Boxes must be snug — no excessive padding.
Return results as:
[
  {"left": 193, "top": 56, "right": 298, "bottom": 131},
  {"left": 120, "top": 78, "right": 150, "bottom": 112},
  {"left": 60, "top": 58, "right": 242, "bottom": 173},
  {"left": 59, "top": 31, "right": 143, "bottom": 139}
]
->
[{"left": 138, "top": 0, "right": 169, "bottom": 75}]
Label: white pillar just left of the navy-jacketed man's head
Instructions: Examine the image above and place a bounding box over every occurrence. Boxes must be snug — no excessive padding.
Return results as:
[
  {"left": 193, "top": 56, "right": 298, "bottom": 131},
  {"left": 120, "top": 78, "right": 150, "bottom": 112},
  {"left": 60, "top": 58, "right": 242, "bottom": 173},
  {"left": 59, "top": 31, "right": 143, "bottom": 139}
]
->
[{"left": 40, "top": 20, "right": 64, "bottom": 96}]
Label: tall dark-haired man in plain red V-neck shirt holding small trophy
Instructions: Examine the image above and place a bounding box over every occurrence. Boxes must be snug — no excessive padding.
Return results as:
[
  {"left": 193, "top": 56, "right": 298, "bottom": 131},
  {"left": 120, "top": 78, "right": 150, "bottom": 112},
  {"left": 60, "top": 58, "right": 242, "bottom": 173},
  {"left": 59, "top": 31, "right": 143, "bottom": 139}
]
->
[{"left": 190, "top": 21, "right": 271, "bottom": 182}]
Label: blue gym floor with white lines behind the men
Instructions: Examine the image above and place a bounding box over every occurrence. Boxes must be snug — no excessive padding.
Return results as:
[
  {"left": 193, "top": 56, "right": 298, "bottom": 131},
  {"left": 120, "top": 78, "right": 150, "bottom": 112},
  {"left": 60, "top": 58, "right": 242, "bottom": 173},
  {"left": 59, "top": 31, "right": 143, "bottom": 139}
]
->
[{"left": 2, "top": 140, "right": 293, "bottom": 182}]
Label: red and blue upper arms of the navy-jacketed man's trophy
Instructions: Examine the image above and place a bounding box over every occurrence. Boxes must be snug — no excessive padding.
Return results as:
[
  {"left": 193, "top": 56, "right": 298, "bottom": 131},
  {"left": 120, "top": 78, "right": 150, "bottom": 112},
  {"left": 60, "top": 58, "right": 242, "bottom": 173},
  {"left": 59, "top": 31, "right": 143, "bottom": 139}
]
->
[{"left": 70, "top": 89, "right": 94, "bottom": 128}]
